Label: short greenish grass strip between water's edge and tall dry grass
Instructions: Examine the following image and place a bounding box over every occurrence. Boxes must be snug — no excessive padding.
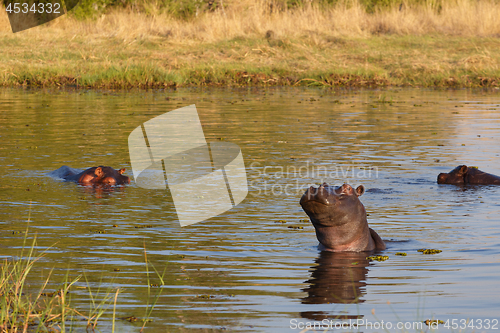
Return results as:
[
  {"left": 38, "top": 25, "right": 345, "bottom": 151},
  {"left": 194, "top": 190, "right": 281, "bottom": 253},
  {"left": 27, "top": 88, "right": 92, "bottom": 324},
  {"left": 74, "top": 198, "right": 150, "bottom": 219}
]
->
[{"left": 0, "top": 36, "right": 500, "bottom": 88}]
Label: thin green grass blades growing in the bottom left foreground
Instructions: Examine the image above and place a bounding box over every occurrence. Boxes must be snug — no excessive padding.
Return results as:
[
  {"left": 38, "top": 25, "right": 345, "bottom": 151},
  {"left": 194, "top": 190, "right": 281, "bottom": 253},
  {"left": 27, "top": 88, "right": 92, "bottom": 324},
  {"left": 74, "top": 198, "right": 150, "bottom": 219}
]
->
[{"left": 0, "top": 218, "right": 166, "bottom": 333}]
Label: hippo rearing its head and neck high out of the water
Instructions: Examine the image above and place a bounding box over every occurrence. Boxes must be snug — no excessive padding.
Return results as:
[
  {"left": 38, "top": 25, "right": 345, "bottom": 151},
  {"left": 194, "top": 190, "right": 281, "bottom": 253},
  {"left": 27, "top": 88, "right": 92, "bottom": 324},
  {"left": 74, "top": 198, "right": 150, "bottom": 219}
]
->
[{"left": 300, "top": 183, "right": 385, "bottom": 252}]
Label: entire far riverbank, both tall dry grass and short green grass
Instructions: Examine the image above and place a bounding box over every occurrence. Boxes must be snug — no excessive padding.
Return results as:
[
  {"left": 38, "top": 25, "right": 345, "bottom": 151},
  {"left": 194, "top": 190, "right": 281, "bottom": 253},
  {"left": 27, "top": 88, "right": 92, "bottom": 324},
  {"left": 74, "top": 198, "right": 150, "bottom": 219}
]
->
[{"left": 0, "top": 0, "right": 500, "bottom": 88}]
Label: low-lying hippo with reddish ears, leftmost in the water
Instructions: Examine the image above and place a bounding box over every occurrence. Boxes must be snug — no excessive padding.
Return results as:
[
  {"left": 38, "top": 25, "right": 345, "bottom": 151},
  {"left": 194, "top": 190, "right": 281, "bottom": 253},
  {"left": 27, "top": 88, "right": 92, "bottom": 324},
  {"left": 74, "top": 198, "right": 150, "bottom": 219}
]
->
[{"left": 49, "top": 165, "right": 130, "bottom": 185}]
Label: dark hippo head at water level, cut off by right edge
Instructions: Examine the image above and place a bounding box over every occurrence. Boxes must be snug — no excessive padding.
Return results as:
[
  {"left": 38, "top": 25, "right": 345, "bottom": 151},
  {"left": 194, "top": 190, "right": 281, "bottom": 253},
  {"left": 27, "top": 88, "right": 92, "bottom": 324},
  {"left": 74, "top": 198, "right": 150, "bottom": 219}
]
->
[{"left": 438, "top": 165, "right": 500, "bottom": 185}]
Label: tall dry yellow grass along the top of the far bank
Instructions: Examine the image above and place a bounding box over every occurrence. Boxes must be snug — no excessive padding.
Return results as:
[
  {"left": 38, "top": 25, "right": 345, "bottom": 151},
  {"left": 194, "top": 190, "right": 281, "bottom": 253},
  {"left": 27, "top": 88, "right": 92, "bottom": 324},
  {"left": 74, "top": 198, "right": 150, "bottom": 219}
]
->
[{"left": 0, "top": 0, "right": 500, "bottom": 42}]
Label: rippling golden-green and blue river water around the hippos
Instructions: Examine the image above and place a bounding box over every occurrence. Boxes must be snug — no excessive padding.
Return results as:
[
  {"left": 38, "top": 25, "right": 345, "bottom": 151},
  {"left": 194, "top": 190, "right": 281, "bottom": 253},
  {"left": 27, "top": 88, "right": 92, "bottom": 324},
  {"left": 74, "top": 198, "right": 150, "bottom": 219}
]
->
[{"left": 0, "top": 88, "right": 500, "bottom": 332}]
